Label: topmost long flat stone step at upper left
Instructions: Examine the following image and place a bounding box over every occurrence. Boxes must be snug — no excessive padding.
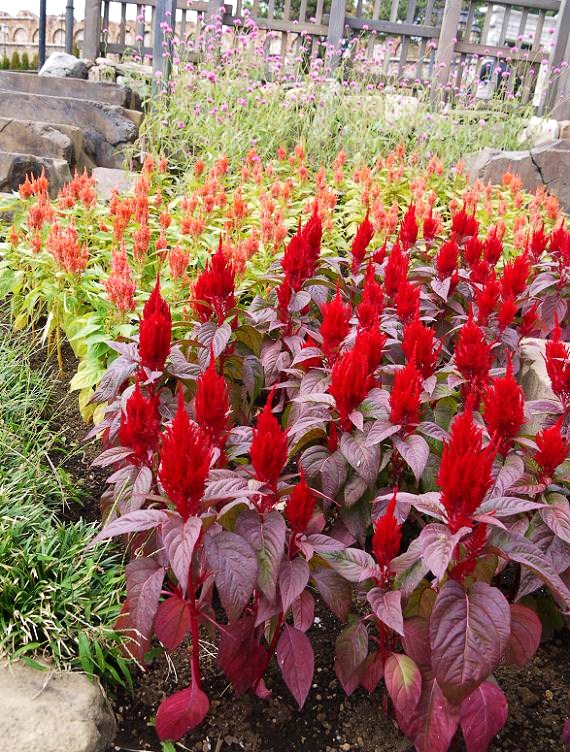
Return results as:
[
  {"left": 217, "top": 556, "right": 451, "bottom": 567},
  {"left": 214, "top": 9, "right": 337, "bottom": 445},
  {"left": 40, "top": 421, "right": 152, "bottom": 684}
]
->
[{"left": 0, "top": 71, "right": 139, "bottom": 114}]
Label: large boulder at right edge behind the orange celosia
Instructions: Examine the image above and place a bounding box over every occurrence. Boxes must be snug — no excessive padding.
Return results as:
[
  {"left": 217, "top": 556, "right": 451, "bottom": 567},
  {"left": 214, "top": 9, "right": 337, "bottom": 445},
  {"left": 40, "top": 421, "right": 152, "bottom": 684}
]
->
[{"left": 466, "top": 139, "right": 570, "bottom": 211}]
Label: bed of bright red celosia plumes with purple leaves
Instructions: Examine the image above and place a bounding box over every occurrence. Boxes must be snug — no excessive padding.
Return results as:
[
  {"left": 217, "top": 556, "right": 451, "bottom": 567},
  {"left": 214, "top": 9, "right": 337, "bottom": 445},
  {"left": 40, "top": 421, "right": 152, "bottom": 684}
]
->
[{"left": 83, "top": 195, "right": 570, "bottom": 752}]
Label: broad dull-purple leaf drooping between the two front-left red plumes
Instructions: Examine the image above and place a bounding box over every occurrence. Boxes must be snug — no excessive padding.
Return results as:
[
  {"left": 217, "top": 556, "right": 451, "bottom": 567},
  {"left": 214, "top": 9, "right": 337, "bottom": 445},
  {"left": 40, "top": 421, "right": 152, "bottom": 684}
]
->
[{"left": 206, "top": 530, "right": 257, "bottom": 621}]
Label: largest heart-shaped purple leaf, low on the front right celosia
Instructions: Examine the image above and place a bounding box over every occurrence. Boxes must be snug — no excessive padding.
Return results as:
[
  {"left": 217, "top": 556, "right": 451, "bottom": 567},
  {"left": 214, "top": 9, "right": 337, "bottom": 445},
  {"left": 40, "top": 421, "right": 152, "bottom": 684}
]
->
[{"left": 430, "top": 580, "right": 511, "bottom": 703}]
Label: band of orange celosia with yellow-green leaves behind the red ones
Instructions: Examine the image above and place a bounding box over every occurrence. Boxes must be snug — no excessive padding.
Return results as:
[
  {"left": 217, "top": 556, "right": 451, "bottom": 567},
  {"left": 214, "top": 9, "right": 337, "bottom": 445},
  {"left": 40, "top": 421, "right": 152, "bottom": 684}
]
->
[{"left": 0, "top": 146, "right": 560, "bottom": 418}]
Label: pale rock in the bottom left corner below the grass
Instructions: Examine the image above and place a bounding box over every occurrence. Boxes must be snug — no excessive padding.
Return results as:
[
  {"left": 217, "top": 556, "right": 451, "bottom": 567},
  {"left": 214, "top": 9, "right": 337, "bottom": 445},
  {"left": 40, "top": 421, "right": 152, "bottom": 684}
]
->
[{"left": 0, "top": 662, "right": 116, "bottom": 752}]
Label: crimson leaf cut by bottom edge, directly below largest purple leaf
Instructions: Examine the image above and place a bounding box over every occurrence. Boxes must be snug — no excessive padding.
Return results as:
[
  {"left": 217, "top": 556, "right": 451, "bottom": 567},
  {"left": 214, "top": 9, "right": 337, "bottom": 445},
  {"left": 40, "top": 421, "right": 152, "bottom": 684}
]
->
[{"left": 459, "top": 681, "right": 509, "bottom": 752}]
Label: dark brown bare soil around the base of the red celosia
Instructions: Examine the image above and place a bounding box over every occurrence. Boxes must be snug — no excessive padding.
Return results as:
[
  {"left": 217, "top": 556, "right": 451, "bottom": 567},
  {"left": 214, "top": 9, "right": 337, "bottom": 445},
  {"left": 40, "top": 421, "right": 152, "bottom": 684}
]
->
[{"left": 38, "top": 340, "right": 570, "bottom": 752}]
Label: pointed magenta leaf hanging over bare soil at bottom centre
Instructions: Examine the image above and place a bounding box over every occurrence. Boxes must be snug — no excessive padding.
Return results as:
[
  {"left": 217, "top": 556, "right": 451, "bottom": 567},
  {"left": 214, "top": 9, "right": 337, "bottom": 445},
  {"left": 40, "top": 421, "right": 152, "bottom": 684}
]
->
[{"left": 276, "top": 624, "right": 315, "bottom": 708}]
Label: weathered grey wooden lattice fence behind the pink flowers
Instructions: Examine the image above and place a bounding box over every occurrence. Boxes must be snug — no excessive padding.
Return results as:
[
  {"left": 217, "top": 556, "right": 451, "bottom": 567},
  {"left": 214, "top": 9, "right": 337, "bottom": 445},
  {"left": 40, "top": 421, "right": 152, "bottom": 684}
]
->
[{"left": 83, "top": 0, "right": 570, "bottom": 119}]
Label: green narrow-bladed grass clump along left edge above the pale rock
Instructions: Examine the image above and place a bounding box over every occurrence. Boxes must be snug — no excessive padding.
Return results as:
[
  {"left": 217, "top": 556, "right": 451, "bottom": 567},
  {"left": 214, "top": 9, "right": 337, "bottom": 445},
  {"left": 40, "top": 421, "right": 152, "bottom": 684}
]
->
[{"left": 0, "top": 325, "right": 130, "bottom": 684}]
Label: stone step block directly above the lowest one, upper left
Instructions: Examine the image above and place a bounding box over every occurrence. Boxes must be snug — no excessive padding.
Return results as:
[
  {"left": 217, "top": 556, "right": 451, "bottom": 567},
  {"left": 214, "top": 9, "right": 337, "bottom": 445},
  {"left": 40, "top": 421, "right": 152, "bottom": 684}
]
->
[{"left": 0, "top": 117, "right": 94, "bottom": 171}]
